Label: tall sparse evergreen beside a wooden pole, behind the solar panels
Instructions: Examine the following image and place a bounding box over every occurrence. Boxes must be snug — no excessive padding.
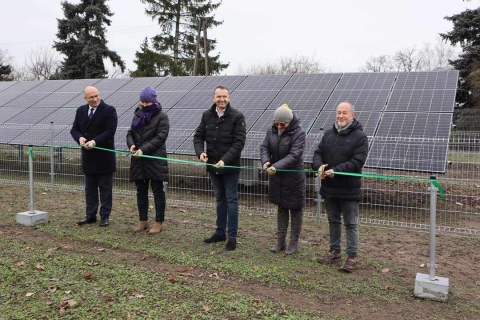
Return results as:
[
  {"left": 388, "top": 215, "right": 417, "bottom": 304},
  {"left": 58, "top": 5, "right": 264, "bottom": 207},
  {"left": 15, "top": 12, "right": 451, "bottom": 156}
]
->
[{"left": 134, "top": 0, "right": 228, "bottom": 76}]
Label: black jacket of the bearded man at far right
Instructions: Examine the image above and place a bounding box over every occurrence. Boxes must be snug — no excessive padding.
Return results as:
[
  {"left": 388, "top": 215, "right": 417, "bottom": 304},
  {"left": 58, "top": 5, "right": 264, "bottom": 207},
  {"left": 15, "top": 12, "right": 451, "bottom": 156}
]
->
[{"left": 312, "top": 119, "right": 368, "bottom": 201}]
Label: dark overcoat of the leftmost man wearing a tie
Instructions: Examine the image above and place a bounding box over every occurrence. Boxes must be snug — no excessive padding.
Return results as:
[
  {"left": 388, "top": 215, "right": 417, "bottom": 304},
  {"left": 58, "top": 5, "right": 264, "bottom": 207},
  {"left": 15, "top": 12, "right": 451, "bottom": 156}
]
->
[{"left": 70, "top": 100, "right": 118, "bottom": 174}]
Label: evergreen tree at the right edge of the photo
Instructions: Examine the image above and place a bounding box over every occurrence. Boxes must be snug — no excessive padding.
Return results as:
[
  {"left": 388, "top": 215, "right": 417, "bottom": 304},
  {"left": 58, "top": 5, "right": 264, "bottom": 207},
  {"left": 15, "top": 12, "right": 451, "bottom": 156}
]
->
[{"left": 440, "top": 8, "right": 480, "bottom": 107}]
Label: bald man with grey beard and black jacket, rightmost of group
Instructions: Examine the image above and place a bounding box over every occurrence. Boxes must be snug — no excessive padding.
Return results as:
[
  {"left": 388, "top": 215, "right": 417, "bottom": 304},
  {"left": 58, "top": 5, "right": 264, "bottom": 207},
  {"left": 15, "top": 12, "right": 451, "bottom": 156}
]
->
[{"left": 312, "top": 102, "right": 368, "bottom": 272}]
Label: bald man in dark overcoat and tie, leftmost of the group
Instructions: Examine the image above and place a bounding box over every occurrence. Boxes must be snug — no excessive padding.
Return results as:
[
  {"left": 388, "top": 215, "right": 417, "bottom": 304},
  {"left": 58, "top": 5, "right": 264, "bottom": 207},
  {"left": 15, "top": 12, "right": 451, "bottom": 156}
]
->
[{"left": 70, "top": 87, "right": 118, "bottom": 227}]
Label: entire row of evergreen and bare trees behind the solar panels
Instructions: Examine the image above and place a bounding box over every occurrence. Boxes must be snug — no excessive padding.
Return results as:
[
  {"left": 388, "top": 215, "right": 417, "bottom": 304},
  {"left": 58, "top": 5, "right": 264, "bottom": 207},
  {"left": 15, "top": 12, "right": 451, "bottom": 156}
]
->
[{"left": 0, "top": 0, "right": 480, "bottom": 107}]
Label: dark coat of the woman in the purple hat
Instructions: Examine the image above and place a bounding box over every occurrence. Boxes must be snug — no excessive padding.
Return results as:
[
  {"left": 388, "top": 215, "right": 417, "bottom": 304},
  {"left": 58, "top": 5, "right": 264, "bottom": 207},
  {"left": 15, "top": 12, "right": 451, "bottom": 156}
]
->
[{"left": 127, "top": 106, "right": 170, "bottom": 181}]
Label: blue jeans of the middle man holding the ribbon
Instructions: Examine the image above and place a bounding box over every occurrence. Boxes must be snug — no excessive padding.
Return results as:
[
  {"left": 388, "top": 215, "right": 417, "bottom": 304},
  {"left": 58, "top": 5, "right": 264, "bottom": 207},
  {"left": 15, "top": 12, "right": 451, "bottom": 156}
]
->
[{"left": 210, "top": 172, "right": 240, "bottom": 239}]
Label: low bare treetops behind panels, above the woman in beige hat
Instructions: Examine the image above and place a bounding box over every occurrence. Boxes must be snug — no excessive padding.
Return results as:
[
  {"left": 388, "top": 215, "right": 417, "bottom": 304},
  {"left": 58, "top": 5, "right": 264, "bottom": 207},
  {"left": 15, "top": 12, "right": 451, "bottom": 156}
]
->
[{"left": 237, "top": 55, "right": 325, "bottom": 75}]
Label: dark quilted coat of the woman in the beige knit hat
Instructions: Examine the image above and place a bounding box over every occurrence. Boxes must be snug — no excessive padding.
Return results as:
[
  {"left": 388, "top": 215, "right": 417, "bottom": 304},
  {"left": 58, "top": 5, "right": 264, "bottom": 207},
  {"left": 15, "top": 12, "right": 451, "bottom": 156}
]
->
[{"left": 260, "top": 116, "right": 305, "bottom": 210}]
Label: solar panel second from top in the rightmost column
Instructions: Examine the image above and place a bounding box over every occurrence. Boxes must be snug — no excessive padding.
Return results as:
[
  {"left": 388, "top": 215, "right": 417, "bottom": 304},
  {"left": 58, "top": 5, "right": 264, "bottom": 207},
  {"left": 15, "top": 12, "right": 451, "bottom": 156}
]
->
[{"left": 385, "top": 89, "right": 456, "bottom": 112}]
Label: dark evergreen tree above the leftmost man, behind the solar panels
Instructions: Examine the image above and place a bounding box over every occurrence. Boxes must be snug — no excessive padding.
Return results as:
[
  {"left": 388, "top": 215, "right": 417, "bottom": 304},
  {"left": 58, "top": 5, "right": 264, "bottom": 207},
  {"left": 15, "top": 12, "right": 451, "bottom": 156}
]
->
[{"left": 53, "top": 0, "right": 125, "bottom": 79}]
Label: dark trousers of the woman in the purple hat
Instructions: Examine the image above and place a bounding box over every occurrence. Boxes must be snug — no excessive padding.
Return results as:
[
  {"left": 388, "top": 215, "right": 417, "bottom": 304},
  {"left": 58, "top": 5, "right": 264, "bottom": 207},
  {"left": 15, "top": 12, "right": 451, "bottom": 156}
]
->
[{"left": 135, "top": 180, "right": 166, "bottom": 223}]
